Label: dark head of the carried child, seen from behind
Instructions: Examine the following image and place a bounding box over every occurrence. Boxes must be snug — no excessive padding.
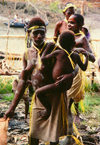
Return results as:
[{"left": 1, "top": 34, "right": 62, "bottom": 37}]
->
[{"left": 59, "top": 31, "right": 75, "bottom": 51}]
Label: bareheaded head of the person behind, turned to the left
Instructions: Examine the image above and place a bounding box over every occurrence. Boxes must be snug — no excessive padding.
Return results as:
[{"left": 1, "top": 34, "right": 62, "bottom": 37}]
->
[{"left": 68, "top": 14, "right": 84, "bottom": 33}]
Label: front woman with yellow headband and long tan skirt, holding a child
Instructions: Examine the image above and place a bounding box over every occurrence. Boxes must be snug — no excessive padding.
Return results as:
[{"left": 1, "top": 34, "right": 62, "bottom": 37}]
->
[{"left": 4, "top": 17, "right": 78, "bottom": 145}]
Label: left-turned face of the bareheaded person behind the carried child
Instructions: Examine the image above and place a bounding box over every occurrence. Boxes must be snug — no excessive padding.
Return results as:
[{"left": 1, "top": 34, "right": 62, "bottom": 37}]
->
[{"left": 67, "top": 15, "right": 79, "bottom": 33}]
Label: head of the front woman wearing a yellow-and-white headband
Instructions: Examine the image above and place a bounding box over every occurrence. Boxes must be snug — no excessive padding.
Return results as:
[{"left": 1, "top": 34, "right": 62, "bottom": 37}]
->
[{"left": 27, "top": 17, "right": 46, "bottom": 46}]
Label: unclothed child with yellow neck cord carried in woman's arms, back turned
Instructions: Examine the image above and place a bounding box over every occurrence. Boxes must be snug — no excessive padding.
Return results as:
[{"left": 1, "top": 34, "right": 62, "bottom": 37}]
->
[{"left": 36, "top": 31, "right": 88, "bottom": 115}]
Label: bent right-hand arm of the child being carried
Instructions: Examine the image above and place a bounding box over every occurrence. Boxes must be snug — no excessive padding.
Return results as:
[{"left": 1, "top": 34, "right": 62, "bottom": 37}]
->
[{"left": 75, "top": 51, "right": 89, "bottom": 71}]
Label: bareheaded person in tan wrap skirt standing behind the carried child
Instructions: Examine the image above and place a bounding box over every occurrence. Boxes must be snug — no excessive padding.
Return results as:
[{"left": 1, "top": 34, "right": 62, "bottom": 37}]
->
[{"left": 68, "top": 14, "right": 95, "bottom": 118}]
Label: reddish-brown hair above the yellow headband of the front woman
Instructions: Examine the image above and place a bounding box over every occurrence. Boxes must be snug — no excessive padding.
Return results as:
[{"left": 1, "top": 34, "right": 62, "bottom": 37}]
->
[{"left": 28, "top": 17, "right": 46, "bottom": 29}]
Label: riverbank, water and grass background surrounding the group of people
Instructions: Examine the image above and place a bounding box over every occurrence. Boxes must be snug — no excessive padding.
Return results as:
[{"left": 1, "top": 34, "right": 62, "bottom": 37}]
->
[{"left": 0, "top": 0, "right": 100, "bottom": 145}]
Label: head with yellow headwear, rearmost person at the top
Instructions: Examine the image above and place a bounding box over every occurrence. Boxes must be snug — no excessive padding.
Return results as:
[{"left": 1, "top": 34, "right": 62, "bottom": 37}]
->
[{"left": 63, "top": 2, "right": 76, "bottom": 20}]
